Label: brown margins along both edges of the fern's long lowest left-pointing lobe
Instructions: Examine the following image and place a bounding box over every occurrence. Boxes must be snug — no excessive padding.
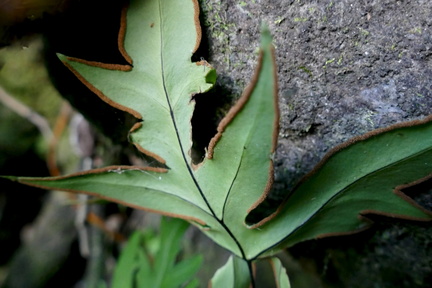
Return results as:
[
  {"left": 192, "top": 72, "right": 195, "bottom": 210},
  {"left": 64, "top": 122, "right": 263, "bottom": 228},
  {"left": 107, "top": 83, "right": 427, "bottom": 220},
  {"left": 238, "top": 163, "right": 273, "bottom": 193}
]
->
[{"left": 13, "top": 165, "right": 207, "bottom": 229}]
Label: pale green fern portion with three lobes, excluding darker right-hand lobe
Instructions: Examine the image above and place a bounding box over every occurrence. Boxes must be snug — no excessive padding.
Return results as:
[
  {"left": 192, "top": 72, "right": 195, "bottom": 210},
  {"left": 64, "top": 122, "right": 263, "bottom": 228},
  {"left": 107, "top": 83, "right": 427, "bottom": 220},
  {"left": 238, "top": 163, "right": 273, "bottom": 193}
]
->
[{"left": 11, "top": 0, "right": 279, "bottom": 258}]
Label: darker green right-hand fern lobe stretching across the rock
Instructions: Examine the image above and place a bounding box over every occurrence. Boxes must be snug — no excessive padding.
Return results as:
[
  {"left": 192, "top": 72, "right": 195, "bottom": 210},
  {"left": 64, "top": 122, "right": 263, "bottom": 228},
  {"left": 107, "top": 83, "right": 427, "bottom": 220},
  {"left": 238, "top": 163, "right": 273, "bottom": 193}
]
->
[{"left": 246, "top": 116, "right": 432, "bottom": 256}]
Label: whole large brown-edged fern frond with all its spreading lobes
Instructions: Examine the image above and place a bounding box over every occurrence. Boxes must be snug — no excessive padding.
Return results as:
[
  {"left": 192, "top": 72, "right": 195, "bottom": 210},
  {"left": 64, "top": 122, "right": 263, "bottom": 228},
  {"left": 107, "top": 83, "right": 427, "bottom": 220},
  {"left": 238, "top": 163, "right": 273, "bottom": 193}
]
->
[{"left": 5, "top": 0, "right": 432, "bottom": 276}]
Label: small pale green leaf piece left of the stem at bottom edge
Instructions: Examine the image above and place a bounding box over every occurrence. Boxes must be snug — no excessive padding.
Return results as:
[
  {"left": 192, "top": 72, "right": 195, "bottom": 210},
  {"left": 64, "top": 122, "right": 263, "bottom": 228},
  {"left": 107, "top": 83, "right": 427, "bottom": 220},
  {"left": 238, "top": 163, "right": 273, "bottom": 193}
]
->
[{"left": 210, "top": 256, "right": 250, "bottom": 288}]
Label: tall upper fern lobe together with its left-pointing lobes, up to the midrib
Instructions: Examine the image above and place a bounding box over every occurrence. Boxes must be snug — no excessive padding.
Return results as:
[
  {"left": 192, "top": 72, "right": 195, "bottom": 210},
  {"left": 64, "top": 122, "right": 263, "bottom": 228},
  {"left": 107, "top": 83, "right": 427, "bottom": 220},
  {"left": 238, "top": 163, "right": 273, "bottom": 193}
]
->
[{"left": 16, "top": 0, "right": 218, "bottom": 230}]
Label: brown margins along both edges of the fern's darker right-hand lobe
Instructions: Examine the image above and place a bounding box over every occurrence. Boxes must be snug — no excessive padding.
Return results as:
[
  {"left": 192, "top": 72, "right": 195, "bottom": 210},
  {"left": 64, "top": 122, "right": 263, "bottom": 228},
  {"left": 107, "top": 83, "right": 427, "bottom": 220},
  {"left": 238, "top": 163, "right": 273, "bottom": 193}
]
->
[{"left": 251, "top": 115, "right": 432, "bottom": 231}]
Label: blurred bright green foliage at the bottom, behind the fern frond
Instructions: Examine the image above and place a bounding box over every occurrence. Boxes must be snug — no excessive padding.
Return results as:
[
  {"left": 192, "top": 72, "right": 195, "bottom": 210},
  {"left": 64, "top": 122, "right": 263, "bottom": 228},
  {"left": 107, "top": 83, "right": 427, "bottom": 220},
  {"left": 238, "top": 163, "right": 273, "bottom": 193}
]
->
[{"left": 112, "top": 218, "right": 202, "bottom": 288}]
